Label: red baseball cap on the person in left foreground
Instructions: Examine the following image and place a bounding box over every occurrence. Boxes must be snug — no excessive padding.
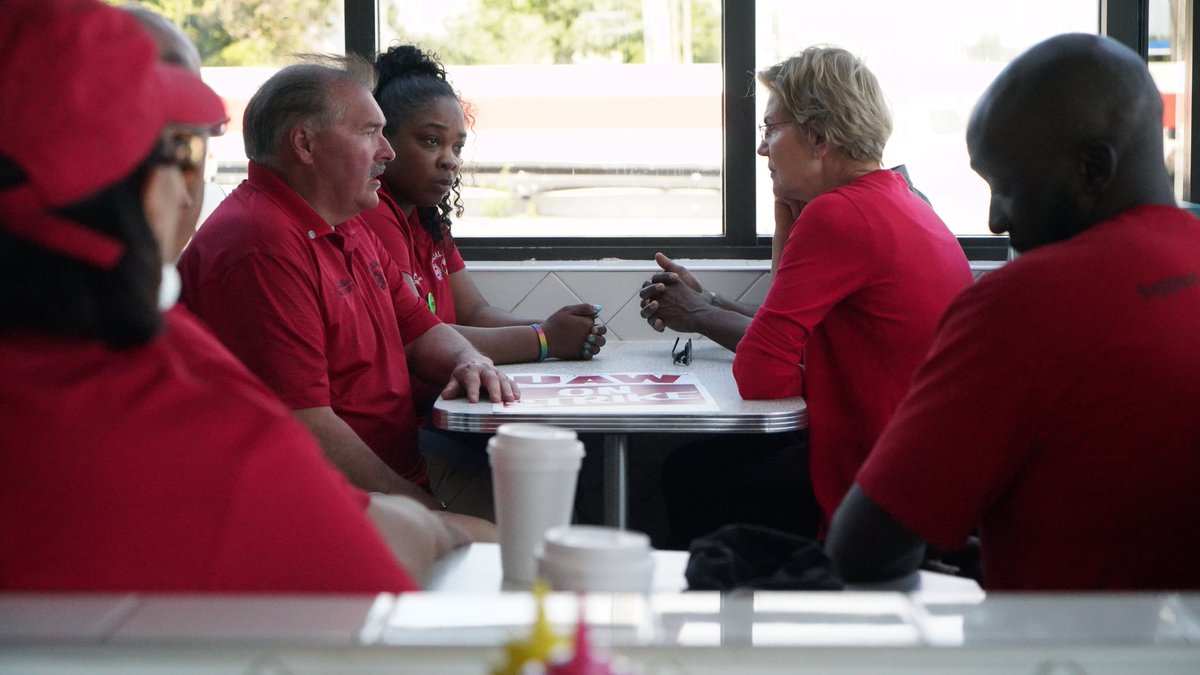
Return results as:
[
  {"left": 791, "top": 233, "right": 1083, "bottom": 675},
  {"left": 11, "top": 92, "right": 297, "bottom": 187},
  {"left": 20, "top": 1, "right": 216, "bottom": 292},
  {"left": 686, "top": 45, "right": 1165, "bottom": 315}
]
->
[{"left": 0, "top": 0, "right": 227, "bottom": 269}]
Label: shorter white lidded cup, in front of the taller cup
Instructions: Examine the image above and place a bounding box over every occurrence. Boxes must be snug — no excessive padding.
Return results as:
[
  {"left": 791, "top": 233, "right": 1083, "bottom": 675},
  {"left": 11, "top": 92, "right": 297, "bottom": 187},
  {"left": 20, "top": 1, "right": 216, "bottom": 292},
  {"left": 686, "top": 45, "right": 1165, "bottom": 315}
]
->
[{"left": 535, "top": 525, "right": 654, "bottom": 593}]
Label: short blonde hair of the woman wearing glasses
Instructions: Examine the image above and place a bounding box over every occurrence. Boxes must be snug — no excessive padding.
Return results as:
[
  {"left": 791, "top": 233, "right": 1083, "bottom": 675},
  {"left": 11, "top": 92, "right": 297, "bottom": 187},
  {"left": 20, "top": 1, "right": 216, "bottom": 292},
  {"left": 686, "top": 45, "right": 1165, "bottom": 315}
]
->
[{"left": 758, "top": 46, "right": 892, "bottom": 162}]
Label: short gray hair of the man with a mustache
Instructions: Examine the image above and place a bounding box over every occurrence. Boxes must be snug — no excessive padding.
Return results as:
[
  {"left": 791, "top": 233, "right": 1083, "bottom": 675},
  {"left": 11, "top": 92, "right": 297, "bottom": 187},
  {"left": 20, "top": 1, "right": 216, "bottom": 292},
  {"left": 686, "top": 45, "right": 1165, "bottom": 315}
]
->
[{"left": 242, "top": 54, "right": 376, "bottom": 166}]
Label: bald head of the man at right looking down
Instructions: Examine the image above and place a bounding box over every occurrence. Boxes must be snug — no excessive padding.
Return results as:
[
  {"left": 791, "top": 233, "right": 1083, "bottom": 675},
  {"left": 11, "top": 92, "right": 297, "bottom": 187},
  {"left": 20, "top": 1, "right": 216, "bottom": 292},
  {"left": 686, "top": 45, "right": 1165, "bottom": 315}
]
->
[{"left": 967, "top": 34, "right": 1174, "bottom": 251}]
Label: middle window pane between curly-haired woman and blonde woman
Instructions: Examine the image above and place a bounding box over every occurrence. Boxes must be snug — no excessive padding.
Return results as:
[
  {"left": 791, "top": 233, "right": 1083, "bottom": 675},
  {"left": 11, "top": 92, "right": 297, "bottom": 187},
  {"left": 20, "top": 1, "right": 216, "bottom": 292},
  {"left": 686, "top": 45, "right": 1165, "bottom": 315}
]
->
[{"left": 379, "top": 0, "right": 722, "bottom": 240}]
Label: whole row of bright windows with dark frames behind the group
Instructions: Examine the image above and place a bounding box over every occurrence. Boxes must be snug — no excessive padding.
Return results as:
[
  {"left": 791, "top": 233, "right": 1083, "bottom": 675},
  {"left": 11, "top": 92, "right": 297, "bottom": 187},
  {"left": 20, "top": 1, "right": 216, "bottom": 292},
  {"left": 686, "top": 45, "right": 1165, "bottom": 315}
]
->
[{"left": 157, "top": 0, "right": 1161, "bottom": 259}]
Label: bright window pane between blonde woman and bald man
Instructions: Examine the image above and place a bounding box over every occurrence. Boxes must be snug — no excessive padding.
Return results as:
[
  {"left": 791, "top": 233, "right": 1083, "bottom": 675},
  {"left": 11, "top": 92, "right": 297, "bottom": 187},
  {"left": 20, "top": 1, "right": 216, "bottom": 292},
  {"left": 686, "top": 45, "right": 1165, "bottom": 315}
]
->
[{"left": 755, "top": 0, "right": 1099, "bottom": 237}]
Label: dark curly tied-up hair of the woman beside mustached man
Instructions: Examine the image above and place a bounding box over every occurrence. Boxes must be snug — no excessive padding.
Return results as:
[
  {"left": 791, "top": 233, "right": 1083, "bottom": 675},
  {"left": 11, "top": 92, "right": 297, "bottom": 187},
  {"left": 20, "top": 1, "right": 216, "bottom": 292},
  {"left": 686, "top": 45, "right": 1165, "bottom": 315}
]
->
[{"left": 374, "top": 44, "right": 472, "bottom": 245}]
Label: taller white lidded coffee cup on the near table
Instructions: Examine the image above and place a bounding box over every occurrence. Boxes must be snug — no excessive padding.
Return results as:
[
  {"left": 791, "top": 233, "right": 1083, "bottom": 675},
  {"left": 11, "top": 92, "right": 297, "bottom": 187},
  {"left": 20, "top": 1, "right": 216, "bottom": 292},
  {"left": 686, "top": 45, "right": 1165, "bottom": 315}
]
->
[{"left": 487, "top": 424, "right": 583, "bottom": 583}]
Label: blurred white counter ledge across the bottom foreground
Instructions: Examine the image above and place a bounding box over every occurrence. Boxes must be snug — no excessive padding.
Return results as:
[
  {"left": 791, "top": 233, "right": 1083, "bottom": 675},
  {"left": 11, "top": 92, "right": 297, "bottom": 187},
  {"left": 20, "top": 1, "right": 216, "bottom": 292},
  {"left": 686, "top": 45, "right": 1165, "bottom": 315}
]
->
[{"left": 0, "top": 581, "right": 1200, "bottom": 675}]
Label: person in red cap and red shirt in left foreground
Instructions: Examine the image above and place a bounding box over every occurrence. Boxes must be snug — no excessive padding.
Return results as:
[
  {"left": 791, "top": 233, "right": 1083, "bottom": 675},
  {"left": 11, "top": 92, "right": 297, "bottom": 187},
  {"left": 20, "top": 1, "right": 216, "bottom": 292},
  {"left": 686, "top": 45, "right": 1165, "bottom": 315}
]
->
[{"left": 0, "top": 0, "right": 466, "bottom": 593}]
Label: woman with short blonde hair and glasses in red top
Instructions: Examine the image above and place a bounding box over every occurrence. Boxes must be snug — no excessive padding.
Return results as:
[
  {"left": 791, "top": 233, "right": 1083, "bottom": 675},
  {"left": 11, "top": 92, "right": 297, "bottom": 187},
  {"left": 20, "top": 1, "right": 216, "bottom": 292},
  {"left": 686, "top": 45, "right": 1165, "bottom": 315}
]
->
[{"left": 641, "top": 46, "right": 972, "bottom": 545}]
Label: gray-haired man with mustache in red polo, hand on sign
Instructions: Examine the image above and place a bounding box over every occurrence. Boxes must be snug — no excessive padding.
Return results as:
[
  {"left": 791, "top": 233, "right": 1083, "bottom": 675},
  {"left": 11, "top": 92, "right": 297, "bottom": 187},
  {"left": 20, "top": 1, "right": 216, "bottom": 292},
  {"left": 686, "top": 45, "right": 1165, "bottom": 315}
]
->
[{"left": 180, "top": 58, "right": 517, "bottom": 516}]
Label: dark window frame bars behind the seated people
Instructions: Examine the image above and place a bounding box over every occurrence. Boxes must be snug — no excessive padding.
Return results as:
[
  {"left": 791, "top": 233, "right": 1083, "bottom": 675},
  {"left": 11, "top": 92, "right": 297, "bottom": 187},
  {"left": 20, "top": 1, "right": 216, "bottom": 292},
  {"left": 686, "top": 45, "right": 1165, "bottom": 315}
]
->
[{"left": 343, "top": 0, "right": 1156, "bottom": 261}]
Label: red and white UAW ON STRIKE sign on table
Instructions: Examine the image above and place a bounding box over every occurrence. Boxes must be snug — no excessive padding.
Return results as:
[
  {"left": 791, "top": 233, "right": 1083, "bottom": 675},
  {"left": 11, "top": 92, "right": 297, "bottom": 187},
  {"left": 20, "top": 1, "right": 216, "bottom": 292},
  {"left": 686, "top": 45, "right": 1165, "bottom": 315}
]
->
[{"left": 492, "top": 372, "right": 718, "bottom": 414}]
